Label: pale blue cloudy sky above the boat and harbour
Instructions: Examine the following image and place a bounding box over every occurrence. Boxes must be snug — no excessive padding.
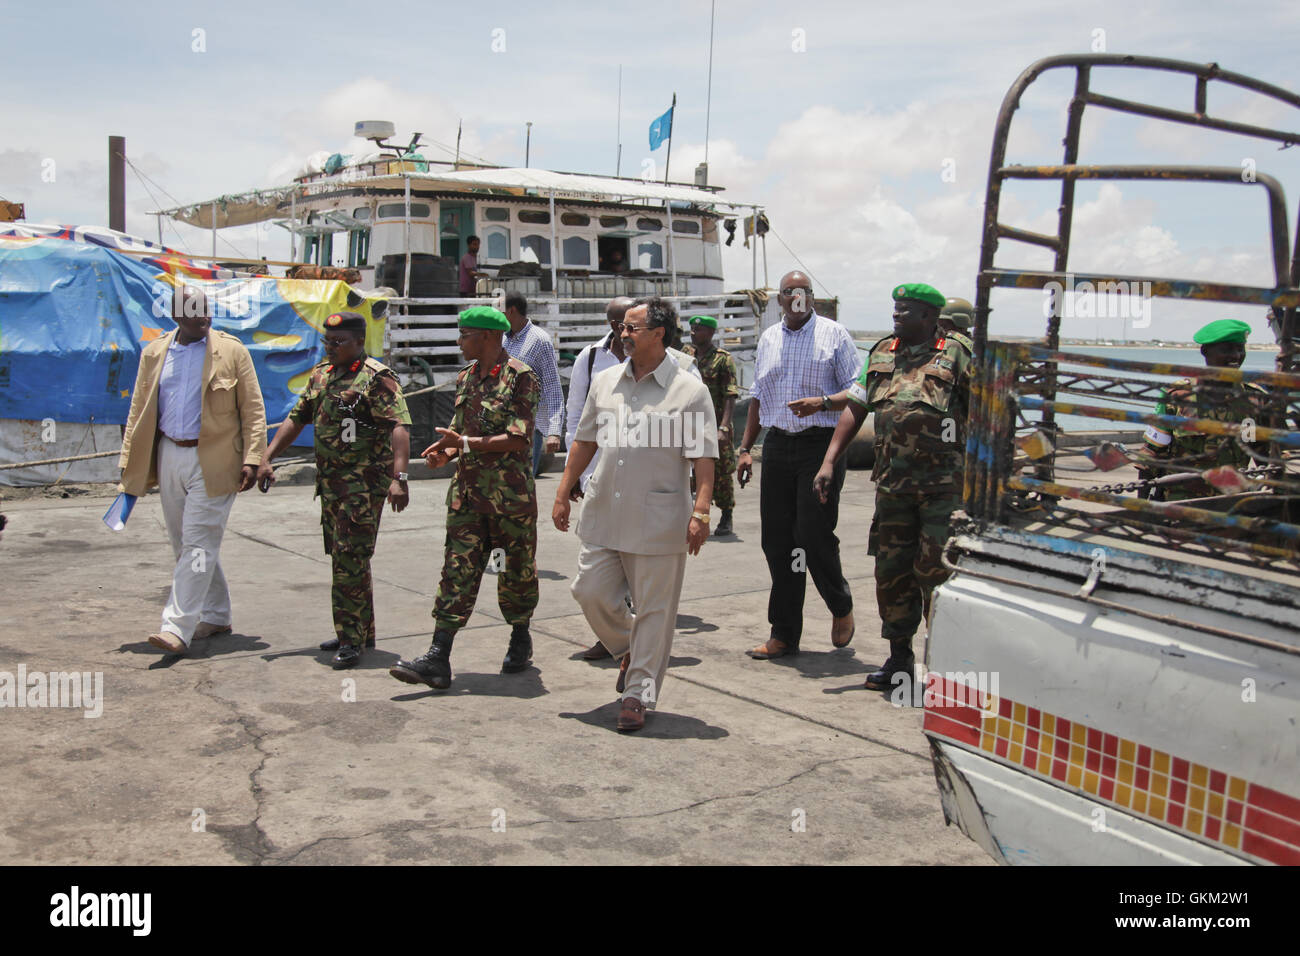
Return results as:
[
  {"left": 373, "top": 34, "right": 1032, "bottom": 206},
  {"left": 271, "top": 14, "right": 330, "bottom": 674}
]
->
[{"left": 0, "top": 0, "right": 1300, "bottom": 341}]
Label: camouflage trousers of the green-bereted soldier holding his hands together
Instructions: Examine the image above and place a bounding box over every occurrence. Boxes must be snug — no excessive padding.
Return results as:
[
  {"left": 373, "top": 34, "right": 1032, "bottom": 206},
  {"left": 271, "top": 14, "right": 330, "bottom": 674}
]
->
[{"left": 433, "top": 510, "right": 537, "bottom": 631}]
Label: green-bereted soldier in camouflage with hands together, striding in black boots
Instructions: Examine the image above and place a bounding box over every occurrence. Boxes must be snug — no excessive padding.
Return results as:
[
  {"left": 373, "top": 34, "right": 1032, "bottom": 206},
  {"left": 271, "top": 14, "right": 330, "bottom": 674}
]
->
[{"left": 389, "top": 306, "right": 541, "bottom": 689}]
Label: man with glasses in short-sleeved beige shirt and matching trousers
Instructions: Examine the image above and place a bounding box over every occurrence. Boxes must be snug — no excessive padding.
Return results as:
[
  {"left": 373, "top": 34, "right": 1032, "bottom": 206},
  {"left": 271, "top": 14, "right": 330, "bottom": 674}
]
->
[{"left": 551, "top": 298, "right": 718, "bottom": 731}]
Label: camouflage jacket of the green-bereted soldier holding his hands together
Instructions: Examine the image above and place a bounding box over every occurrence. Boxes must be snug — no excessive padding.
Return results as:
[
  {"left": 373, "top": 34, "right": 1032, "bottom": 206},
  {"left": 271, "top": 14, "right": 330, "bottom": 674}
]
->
[{"left": 447, "top": 358, "right": 542, "bottom": 515}]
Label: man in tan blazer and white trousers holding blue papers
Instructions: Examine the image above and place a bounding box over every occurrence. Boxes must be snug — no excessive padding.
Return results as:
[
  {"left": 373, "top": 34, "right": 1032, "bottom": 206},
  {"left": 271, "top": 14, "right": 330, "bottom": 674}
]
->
[{"left": 118, "top": 286, "right": 267, "bottom": 654}]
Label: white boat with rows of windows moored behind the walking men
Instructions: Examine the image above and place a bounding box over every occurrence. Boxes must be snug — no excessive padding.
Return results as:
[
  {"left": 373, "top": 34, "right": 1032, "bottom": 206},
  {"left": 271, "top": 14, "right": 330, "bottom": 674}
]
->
[{"left": 156, "top": 122, "right": 777, "bottom": 384}]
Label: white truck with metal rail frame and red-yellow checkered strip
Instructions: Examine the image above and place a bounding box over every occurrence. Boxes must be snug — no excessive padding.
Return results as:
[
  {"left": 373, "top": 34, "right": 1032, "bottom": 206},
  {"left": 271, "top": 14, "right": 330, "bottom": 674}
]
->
[{"left": 924, "top": 56, "right": 1300, "bottom": 865}]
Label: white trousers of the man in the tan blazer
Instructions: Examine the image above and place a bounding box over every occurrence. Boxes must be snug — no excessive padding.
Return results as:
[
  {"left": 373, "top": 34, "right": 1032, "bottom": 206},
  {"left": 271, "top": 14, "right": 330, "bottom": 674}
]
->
[{"left": 159, "top": 436, "right": 235, "bottom": 646}]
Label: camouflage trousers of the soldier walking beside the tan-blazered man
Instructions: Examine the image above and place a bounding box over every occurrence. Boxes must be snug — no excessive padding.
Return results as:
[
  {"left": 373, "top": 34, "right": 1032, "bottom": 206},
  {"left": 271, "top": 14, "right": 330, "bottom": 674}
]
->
[{"left": 321, "top": 492, "right": 386, "bottom": 646}]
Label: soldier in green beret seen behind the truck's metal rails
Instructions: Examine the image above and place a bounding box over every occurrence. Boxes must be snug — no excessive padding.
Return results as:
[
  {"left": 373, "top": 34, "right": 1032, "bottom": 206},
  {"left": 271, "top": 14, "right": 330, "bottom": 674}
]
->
[{"left": 1138, "top": 319, "right": 1271, "bottom": 501}]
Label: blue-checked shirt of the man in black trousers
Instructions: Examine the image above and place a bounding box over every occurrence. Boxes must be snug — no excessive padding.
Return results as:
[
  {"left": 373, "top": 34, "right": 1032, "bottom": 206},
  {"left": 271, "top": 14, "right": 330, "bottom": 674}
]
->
[{"left": 751, "top": 313, "right": 862, "bottom": 432}]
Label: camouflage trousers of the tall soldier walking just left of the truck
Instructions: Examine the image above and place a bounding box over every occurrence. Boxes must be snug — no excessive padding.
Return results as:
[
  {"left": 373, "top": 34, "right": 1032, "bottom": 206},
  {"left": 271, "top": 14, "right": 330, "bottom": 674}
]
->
[{"left": 867, "top": 489, "right": 962, "bottom": 641}]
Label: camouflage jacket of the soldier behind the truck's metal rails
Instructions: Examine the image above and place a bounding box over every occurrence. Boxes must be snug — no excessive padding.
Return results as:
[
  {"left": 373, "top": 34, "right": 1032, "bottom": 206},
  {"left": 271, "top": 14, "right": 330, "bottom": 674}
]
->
[{"left": 1139, "top": 378, "right": 1274, "bottom": 501}]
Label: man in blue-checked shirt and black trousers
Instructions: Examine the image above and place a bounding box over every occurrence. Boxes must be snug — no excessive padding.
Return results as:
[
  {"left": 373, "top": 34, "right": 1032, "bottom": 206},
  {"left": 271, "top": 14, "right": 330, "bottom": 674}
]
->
[{"left": 736, "top": 272, "right": 862, "bottom": 661}]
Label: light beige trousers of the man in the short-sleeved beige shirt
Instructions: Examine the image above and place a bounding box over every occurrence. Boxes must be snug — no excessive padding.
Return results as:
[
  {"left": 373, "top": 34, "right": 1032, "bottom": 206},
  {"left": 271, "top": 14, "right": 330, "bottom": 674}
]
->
[{"left": 571, "top": 544, "right": 686, "bottom": 710}]
